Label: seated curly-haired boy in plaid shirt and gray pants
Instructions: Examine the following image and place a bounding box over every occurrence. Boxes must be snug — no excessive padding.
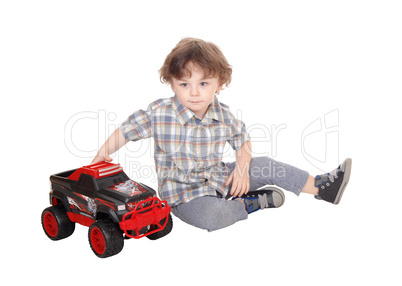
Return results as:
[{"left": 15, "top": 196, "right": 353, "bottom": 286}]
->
[{"left": 93, "top": 38, "right": 351, "bottom": 231}]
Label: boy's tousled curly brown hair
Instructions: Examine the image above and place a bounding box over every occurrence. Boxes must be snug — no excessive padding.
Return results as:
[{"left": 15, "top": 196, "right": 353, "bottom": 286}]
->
[{"left": 159, "top": 38, "right": 232, "bottom": 86}]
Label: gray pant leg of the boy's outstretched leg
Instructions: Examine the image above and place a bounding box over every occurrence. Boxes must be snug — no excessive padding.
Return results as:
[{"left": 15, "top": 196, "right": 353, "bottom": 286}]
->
[{"left": 225, "top": 156, "right": 309, "bottom": 195}]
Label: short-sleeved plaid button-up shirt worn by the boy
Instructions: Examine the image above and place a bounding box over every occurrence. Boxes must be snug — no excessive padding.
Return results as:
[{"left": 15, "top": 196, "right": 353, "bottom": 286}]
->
[{"left": 121, "top": 96, "right": 250, "bottom": 206}]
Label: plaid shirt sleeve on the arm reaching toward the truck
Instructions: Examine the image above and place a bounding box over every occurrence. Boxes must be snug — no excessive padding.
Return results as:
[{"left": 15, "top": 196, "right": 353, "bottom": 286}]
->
[{"left": 120, "top": 109, "right": 153, "bottom": 141}]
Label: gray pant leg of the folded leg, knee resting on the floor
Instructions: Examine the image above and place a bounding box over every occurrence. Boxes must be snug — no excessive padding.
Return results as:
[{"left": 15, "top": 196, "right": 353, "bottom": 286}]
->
[{"left": 172, "top": 196, "right": 248, "bottom": 231}]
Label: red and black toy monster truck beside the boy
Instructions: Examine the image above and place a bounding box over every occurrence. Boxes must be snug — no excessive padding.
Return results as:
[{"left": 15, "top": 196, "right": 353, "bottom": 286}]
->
[{"left": 42, "top": 162, "right": 173, "bottom": 258}]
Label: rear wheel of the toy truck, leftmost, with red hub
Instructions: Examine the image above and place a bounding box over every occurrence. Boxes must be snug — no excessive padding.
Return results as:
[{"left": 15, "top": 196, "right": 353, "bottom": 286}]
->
[{"left": 42, "top": 205, "right": 75, "bottom": 240}]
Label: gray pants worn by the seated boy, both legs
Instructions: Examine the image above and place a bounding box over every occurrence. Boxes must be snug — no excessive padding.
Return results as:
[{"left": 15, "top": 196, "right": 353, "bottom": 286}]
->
[{"left": 172, "top": 157, "right": 308, "bottom": 231}]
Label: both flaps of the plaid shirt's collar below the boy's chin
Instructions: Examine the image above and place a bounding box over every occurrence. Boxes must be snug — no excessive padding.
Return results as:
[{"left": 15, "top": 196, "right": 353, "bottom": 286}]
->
[{"left": 172, "top": 94, "right": 223, "bottom": 125}]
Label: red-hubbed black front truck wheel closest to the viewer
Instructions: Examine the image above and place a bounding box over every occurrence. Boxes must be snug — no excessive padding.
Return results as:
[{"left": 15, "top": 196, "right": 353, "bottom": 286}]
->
[{"left": 88, "top": 220, "right": 124, "bottom": 258}]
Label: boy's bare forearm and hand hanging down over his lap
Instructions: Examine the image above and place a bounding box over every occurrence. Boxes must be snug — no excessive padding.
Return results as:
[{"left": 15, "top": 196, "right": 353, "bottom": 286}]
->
[{"left": 225, "top": 141, "right": 251, "bottom": 197}]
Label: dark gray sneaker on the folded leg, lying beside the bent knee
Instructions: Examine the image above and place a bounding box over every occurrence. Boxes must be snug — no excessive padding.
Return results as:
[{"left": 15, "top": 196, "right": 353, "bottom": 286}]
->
[{"left": 235, "top": 187, "right": 285, "bottom": 213}]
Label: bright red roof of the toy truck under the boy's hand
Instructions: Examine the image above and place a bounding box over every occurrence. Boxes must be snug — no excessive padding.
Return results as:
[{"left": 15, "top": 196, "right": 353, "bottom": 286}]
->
[{"left": 68, "top": 162, "right": 123, "bottom": 181}]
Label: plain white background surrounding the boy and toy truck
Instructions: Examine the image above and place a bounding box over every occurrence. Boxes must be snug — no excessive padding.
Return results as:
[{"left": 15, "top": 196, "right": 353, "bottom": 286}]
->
[{"left": 0, "top": 0, "right": 402, "bottom": 285}]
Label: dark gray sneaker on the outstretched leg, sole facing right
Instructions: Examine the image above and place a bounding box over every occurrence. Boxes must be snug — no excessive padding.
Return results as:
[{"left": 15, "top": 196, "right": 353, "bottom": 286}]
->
[{"left": 315, "top": 158, "right": 352, "bottom": 204}]
